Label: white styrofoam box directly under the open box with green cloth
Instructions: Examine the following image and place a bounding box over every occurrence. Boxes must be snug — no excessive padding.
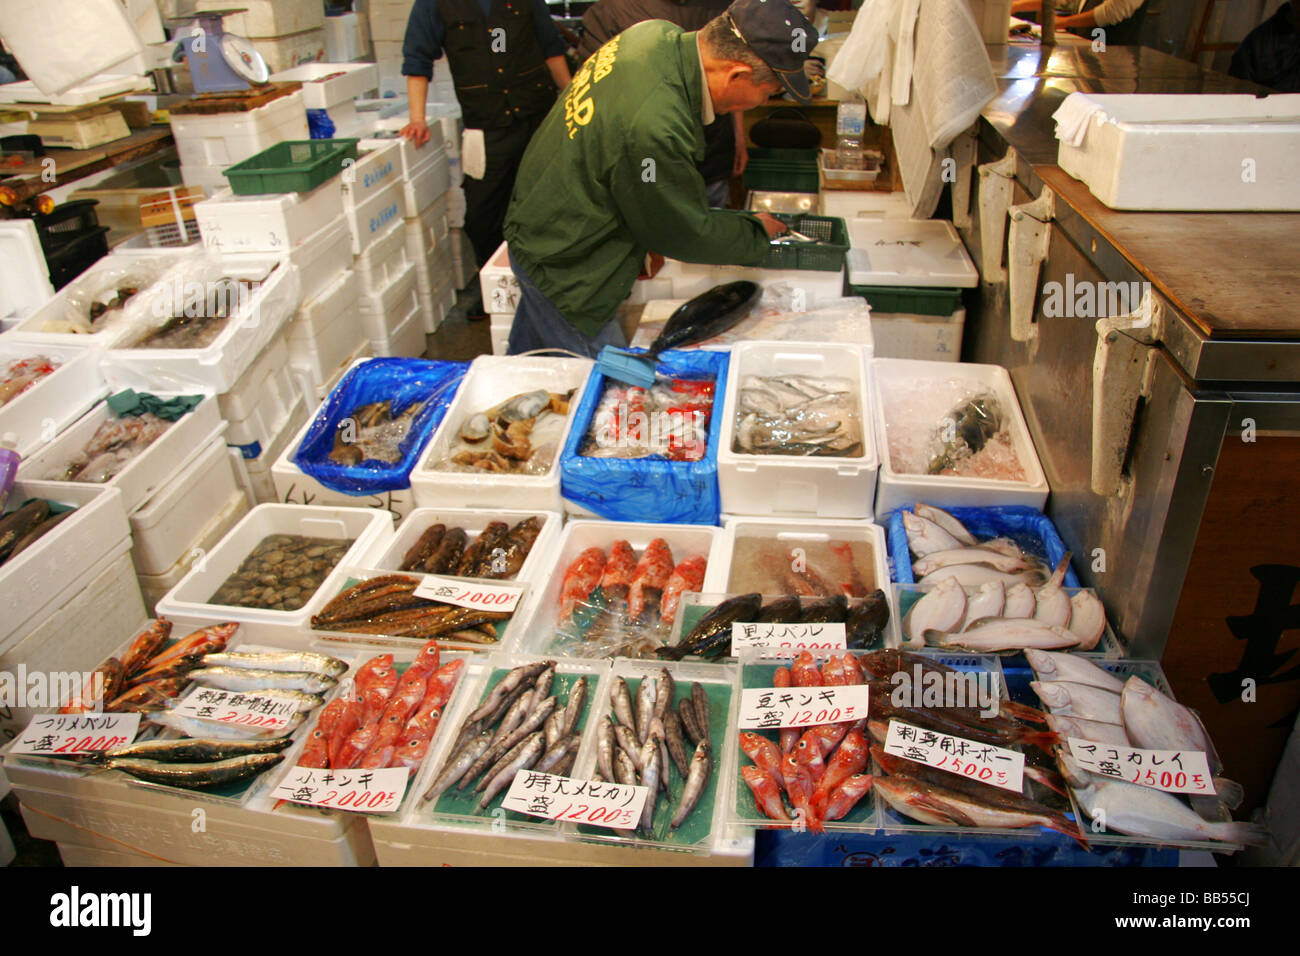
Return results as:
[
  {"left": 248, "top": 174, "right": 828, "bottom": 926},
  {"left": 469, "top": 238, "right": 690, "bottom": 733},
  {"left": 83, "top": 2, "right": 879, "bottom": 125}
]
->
[{"left": 130, "top": 431, "right": 247, "bottom": 575}]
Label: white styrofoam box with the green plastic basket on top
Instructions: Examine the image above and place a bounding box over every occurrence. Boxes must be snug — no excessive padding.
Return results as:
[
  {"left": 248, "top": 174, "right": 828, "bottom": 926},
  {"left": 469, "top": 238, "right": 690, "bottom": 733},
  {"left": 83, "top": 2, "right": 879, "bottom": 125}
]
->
[{"left": 194, "top": 176, "right": 343, "bottom": 254}]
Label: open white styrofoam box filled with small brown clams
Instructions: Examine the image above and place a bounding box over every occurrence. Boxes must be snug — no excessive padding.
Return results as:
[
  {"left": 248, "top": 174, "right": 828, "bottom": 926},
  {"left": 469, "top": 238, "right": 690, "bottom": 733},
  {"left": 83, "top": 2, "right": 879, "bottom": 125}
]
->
[{"left": 157, "top": 505, "right": 393, "bottom": 640}]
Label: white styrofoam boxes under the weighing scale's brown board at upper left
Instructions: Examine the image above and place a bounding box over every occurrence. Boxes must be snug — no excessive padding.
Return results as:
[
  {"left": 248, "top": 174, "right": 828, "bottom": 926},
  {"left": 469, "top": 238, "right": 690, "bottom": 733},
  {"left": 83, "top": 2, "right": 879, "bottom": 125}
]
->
[{"left": 170, "top": 90, "right": 309, "bottom": 195}]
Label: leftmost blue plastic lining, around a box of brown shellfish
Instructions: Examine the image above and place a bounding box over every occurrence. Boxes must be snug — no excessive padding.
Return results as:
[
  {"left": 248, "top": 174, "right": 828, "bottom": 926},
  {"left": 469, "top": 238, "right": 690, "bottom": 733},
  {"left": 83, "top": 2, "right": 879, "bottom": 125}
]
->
[{"left": 293, "top": 358, "right": 469, "bottom": 494}]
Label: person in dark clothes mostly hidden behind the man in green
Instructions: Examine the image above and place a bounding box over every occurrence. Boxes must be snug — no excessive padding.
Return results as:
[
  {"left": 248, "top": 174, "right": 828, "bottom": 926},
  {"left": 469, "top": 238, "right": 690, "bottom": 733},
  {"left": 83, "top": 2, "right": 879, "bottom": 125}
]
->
[{"left": 577, "top": 0, "right": 749, "bottom": 208}]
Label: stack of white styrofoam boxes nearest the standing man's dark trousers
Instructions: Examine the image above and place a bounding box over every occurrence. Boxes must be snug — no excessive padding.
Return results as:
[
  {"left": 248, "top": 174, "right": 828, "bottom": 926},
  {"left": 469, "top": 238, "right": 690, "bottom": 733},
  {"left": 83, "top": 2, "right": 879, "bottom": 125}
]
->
[{"left": 361, "top": 117, "right": 456, "bottom": 333}]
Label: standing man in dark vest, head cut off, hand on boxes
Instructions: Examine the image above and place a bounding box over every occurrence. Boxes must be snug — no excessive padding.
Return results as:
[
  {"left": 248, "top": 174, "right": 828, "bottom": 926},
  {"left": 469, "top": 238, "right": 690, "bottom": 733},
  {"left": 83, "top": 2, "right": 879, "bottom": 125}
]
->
[{"left": 402, "top": 0, "right": 569, "bottom": 319}]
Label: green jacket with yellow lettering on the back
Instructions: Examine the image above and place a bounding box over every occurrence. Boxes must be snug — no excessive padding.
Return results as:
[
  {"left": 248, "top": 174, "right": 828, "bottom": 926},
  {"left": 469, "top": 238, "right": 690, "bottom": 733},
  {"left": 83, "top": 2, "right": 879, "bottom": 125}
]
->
[{"left": 504, "top": 20, "right": 770, "bottom": 336}]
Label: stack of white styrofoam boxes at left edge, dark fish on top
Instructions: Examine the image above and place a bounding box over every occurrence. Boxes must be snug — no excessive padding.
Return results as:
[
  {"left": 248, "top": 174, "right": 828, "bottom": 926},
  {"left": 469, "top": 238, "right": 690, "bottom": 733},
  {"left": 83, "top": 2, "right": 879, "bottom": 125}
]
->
[{"left": 0, "top": 481, "right": 144, "bottom": 741}]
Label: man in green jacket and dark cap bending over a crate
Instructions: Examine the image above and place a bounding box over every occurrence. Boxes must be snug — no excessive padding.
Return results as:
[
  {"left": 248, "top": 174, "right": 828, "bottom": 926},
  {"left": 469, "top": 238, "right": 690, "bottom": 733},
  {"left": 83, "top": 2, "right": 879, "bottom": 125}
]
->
[{"left": 504, "top": 0, "right": 818, "bottom": 356}]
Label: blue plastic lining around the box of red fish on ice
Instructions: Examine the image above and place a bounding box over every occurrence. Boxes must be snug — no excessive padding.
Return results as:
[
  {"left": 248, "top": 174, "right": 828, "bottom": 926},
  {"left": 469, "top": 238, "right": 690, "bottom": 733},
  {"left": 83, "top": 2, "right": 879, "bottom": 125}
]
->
[{"left": 560, "top": 351, "right": 728, "bottom": 524}]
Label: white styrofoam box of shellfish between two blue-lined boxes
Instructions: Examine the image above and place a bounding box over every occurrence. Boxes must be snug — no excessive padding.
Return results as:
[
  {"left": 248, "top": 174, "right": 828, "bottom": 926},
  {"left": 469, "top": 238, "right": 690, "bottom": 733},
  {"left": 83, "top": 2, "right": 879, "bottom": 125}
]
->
[{"left": 411, "top": 355, "right": 594, "bottom": 511}]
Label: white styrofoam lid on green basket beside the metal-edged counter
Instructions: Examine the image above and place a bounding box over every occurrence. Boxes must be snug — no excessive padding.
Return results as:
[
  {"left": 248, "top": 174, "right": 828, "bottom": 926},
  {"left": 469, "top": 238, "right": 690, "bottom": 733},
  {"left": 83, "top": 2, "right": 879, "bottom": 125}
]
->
[{"left": 846, "top": 219, "right": 979, "bottom": 289}]
